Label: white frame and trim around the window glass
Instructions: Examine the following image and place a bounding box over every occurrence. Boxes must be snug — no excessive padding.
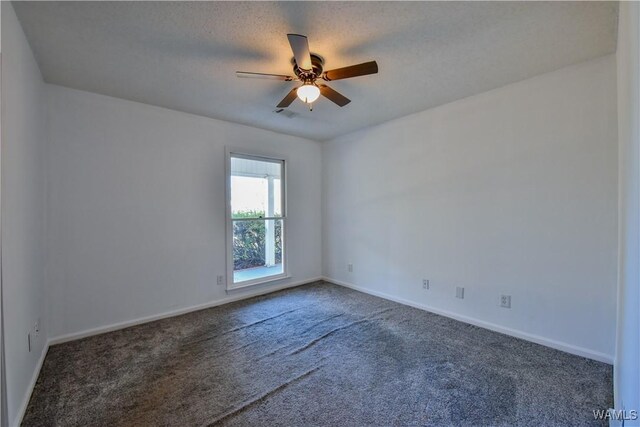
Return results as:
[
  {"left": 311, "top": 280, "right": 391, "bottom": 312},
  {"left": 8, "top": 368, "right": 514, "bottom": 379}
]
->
[{"left": 225, "top": 147, "right": 291, "bottom": 291}]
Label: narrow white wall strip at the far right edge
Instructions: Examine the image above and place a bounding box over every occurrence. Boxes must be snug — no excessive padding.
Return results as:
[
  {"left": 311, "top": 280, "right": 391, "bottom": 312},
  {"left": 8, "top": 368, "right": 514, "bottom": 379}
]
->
[{"left": 614, "top": 2, "right": 640, "bottom": 425}]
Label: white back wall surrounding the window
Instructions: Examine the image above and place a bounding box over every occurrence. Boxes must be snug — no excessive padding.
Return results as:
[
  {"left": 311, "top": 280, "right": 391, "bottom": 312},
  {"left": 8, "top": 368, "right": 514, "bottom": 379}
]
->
[{"left": 47, "top": 86, "right": 321, "bottom": 338}]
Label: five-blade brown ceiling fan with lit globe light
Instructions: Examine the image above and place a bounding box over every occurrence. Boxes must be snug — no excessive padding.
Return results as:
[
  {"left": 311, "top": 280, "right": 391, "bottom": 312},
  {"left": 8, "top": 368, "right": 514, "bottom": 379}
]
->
[{"left": 236, "top": 34, "right": 378, "bottom": 110}]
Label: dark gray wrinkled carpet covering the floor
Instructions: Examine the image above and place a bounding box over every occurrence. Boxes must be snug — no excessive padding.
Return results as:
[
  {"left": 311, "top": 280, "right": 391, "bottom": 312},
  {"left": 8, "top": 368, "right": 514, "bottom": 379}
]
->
[{"left": 23, "top": 283, "right": 612, "bottom": 426}]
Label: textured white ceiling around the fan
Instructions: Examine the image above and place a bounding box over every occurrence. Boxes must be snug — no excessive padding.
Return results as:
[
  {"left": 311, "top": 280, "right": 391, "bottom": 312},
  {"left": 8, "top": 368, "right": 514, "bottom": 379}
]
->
[{"left": 13, "top": 1, "right": 618, "bottom": 140}]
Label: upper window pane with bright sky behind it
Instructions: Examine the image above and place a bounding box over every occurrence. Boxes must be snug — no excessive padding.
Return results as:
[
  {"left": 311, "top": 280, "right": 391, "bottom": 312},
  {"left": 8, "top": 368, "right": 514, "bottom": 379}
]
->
[{"left": 231, "top": 156, "right": 282, "bottom": 218}]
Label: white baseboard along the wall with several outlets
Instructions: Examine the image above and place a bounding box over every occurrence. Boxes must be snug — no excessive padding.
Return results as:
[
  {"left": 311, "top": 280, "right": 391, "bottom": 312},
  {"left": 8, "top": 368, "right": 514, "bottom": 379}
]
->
[{"left": 322, "top": 277, "right": 613, "bottom": 365}]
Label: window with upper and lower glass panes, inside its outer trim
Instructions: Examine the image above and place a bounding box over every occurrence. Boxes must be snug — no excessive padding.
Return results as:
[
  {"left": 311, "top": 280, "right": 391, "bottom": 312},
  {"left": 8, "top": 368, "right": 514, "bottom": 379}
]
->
[{"left": 227, "top": 152, "right": 287, "bottom": 288}]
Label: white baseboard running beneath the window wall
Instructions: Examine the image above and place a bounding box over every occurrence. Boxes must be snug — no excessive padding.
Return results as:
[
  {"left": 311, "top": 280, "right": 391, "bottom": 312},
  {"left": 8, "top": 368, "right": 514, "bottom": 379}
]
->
[{"left": 49, "top": 277, "right": 322, "bottom": 345}]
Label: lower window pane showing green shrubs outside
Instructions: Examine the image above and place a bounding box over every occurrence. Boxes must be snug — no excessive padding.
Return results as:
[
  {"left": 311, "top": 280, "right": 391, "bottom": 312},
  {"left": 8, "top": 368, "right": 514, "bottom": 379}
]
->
[{"left": 233, "top": 219, "right": 284, "bottom": 283}]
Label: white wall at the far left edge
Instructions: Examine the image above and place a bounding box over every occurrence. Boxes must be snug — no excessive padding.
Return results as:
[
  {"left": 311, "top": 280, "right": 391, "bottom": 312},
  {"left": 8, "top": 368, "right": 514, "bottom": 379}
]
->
[{"left": 1, "top": 2, "right": 47, "bottom": 425}]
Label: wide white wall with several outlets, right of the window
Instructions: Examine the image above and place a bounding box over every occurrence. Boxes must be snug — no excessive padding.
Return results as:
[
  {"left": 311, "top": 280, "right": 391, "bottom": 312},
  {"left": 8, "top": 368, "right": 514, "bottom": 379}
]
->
[{"left": 323, "top": 52, "right": 617, "bottom": 362}]
